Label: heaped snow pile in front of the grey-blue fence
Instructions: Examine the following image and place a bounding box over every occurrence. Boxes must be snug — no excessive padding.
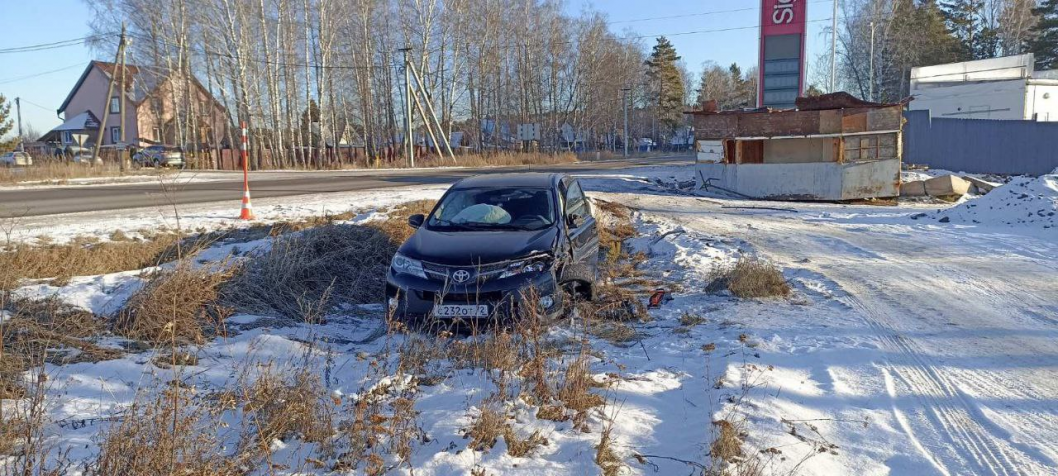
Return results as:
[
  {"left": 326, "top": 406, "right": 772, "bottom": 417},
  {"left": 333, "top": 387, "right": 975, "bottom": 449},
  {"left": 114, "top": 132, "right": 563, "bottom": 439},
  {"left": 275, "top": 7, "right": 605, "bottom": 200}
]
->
[{"left": 936, "top": 173, "right": 1058, "bottom": 228}]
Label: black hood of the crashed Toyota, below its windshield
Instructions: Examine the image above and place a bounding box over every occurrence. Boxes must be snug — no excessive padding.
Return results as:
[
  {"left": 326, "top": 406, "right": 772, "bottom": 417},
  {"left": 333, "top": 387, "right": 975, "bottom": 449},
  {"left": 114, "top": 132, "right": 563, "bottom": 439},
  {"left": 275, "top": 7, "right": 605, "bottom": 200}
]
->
[{"left": 400, "top": 226, "right": 559, "bottom": 266}]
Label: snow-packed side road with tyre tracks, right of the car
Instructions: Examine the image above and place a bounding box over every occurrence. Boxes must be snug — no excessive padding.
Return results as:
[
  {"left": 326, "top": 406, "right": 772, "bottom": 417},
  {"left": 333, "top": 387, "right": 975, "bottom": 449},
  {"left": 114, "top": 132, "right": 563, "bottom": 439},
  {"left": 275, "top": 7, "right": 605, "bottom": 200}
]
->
[{"left": 633, "top": 192, "right": 1058, "bottom": 475}]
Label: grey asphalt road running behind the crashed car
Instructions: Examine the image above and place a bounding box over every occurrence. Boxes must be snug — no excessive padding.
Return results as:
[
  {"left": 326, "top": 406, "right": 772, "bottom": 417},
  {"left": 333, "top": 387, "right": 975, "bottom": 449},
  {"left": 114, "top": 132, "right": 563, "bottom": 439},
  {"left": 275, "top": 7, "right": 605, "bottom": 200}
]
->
[{"left": 0, "top": 155, "right": 693, "bottom": 217}]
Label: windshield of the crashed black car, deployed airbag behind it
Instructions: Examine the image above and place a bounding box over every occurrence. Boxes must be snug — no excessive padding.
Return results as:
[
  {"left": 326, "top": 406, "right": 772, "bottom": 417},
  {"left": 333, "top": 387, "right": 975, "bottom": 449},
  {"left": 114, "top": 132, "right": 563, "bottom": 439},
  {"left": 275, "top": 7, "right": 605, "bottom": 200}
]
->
[{"left": 428, "top": 188, "right": 554, "bottom": 231}]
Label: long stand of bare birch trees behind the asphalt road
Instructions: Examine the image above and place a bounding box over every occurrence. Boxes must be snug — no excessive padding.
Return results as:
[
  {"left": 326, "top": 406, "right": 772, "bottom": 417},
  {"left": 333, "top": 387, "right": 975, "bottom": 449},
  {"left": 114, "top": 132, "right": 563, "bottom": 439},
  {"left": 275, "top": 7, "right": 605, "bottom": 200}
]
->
[{"left": 87, "top": 0, "right": 686, "bottom": 166}]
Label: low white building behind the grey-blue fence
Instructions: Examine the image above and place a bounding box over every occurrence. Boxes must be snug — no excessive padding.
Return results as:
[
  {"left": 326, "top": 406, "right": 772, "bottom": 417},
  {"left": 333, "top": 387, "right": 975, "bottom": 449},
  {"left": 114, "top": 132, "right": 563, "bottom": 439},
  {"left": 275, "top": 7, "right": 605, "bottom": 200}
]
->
[{"left": 910, "top": 53, "right": 1058, "bottom": 122}]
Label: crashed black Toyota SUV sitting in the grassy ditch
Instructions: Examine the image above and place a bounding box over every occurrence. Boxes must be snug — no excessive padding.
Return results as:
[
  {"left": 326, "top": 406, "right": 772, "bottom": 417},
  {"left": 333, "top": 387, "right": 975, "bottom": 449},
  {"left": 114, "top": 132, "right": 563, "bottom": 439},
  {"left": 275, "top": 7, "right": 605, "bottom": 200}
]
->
[{"left": 386, "top": 173, "right": 599, "bottom": 322}]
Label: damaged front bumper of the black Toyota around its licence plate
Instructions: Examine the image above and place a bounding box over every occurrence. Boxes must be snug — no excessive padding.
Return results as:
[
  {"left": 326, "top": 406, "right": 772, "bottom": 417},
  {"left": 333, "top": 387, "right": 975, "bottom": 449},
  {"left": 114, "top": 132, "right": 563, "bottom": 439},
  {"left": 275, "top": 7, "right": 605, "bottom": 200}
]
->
[{"left": 386, "top": 269, "right": 564, "bottom": 323}]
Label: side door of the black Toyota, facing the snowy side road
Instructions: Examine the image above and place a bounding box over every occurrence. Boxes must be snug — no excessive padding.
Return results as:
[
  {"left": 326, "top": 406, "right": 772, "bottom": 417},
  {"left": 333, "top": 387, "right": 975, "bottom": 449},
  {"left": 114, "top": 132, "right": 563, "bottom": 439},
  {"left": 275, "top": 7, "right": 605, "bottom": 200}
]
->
[{"left": 563, "top": 180, "right": 599, "bottom": 281}]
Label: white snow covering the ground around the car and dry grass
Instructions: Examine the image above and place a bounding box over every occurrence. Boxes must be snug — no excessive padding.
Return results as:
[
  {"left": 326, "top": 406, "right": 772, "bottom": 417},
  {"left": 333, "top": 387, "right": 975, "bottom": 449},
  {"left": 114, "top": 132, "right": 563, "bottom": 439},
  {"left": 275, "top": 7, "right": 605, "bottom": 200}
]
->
[{"left": 4, "top": 168, "right": 1058, "bottom": 475}]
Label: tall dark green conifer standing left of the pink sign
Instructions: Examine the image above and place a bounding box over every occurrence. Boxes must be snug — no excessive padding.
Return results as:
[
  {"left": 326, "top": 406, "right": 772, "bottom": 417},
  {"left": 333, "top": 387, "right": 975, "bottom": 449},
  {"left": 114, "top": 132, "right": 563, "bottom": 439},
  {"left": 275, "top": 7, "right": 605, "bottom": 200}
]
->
[{"left": 644, "top": 36, "right": 683, "bottom": 136}]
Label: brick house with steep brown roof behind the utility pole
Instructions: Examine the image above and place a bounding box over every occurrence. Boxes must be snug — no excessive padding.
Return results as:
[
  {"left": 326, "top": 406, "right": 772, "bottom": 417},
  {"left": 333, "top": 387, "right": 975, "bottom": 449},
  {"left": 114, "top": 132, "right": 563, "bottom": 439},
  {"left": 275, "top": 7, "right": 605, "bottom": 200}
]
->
[{"left": 41, "top": 61, "right": 229, "bottom": 148}]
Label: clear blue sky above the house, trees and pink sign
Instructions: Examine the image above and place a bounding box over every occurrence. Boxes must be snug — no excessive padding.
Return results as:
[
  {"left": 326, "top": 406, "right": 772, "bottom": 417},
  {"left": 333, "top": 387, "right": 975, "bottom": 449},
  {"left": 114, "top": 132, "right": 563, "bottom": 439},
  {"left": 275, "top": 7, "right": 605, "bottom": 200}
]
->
[{"left": 0, "top": 0, "right": 832, "bottom": 132}]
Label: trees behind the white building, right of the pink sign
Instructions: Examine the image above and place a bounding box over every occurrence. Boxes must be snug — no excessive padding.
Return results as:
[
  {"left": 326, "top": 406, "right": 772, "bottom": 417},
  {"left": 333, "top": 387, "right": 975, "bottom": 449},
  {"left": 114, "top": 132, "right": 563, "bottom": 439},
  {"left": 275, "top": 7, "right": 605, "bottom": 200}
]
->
[{"left": 833, "top": 0, "right": 1058, "bottom": 102}]
